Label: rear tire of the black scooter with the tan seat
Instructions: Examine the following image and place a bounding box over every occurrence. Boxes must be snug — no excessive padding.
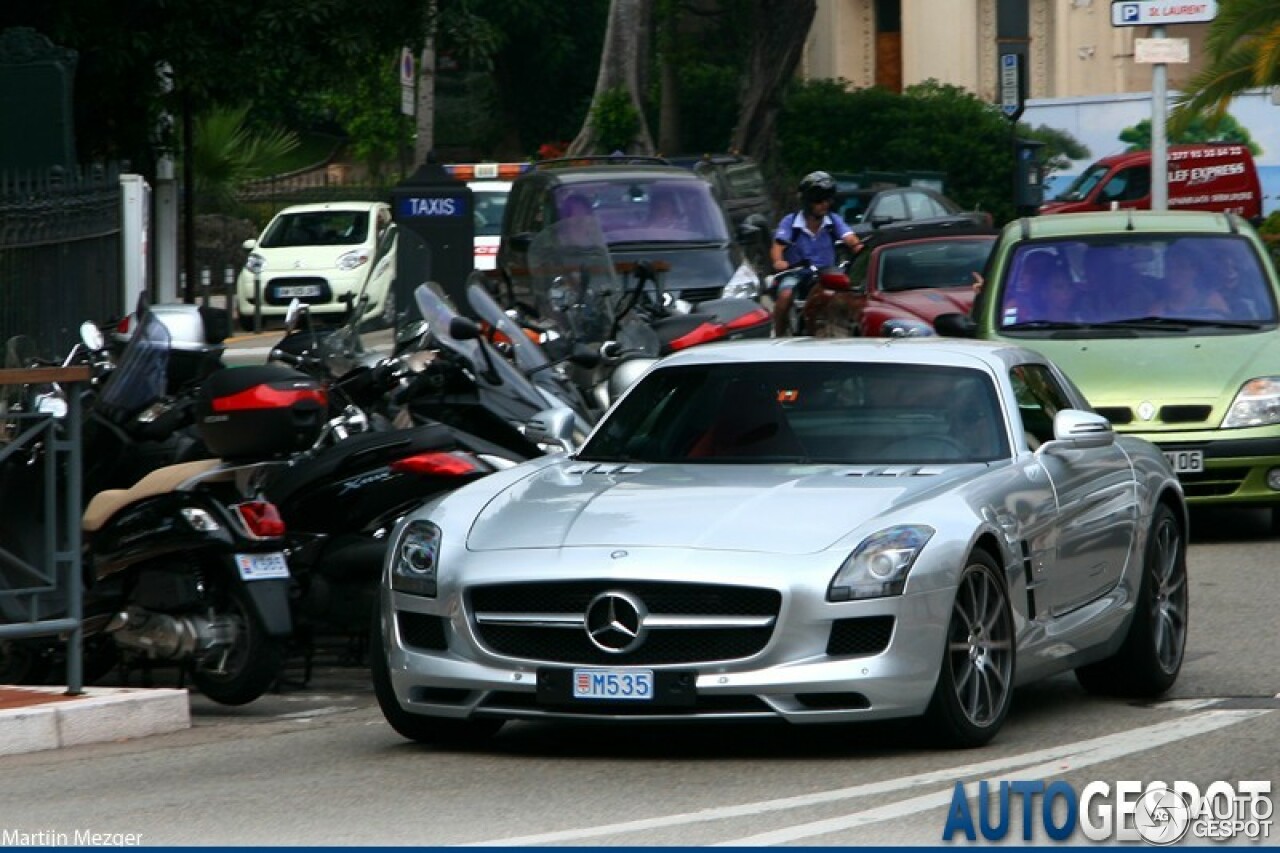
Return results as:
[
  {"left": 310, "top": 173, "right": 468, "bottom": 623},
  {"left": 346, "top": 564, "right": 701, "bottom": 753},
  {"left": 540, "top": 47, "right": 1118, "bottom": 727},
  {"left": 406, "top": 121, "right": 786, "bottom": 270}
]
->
[{"left": 191, "top": 584, "right": 285, "bottom": 704}]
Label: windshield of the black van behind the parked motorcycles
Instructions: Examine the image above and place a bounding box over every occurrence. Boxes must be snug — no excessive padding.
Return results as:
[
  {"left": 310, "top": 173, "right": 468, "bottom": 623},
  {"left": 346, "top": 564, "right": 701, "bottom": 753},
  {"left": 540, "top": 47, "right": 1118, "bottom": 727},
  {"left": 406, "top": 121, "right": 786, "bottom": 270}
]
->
[{"left": 556, "top": 178, "right": 728, "bottom": 245}]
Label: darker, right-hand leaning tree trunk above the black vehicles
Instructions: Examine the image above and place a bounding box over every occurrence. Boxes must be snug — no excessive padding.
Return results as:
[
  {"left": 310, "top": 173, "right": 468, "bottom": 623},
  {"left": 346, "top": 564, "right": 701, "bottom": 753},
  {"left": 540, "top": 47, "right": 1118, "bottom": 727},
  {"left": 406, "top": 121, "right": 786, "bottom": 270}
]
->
[{"left": 732, "top": 0, "right": 818, "bottom": 163}]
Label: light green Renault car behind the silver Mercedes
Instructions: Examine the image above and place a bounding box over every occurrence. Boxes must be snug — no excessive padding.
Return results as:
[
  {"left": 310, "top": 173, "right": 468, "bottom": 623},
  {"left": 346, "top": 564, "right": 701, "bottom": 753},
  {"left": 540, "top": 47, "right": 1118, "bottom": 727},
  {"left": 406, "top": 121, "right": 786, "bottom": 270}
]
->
[{"left": 936, "top": 210, "right": 1280, "bottom": 523}]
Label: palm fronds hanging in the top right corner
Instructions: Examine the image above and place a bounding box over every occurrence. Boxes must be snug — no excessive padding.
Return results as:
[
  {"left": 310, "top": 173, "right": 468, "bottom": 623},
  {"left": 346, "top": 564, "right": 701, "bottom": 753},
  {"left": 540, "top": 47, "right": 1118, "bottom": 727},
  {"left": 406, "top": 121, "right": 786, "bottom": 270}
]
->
[{"left": 1170, "top": 0, "right": 1280, "bottom": 132}]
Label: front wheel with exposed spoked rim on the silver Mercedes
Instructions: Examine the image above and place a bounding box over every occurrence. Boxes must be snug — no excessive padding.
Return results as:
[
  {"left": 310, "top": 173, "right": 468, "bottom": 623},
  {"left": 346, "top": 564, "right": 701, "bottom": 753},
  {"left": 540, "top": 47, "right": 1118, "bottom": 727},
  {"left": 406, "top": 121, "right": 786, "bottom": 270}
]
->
[{"left": 925, "top": 551, "right": 1014, "bottom": 749}]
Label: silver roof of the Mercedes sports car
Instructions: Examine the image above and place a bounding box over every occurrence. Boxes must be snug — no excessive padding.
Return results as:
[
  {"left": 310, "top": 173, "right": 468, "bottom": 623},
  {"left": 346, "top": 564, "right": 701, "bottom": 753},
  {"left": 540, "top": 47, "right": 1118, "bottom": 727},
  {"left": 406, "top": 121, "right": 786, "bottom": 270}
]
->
[{"left": 659, "top": 337, "right": 1047, "bottom": 374}]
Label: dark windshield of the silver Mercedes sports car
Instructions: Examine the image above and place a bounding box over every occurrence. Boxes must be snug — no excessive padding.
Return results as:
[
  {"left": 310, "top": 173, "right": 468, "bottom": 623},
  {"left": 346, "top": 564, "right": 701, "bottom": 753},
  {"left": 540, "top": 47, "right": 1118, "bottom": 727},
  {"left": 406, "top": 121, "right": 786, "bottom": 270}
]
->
[{"left": 579, "top": 361, "right": 1009, "bottom": 465}]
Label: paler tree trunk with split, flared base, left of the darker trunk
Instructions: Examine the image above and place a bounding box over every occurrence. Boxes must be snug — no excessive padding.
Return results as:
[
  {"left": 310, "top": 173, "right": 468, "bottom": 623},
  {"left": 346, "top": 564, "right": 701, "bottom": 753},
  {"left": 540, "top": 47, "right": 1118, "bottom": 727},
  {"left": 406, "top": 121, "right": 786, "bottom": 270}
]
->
[{"left": 568, "top": 0, "right": 653, "bottom": 155}]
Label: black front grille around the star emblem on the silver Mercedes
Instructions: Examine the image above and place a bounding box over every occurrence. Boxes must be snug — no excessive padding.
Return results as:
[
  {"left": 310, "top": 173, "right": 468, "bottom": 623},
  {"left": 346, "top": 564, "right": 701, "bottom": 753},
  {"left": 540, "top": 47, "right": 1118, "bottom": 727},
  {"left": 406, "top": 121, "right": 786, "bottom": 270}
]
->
[{"left": 468, "top": 580, "right": 782, "bottom": 666}]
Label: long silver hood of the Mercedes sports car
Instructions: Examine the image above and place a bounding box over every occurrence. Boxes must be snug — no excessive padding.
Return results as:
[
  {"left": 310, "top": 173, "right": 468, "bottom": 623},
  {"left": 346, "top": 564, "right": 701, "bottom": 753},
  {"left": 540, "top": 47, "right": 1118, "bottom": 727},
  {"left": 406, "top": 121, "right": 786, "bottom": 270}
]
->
[{"left": 467, "top": 461, "right": 986, "bottom": 555}]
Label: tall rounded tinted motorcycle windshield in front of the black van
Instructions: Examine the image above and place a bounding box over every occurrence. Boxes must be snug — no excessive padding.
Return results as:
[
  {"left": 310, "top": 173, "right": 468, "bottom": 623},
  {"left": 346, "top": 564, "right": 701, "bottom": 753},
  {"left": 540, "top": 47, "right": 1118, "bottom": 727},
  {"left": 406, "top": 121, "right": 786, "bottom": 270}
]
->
[{"left": 529, "top": 214, "right": 659, "bottom": 357}]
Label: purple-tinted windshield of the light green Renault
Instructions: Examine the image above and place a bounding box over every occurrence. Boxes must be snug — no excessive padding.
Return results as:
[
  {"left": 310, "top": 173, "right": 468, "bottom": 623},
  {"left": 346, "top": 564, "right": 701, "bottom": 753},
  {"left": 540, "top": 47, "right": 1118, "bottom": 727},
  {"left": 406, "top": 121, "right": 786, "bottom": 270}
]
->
[{"left": 1000, "top": 234, "right": 1276, "bottom": 333}]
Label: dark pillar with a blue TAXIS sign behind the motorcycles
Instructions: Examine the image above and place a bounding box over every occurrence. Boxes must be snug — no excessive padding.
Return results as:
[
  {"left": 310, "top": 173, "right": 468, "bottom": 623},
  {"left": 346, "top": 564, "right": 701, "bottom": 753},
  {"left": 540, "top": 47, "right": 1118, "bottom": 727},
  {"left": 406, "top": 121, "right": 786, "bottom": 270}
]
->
[{"left": 392, "top": 156, "right": 475, "bottom": 319}]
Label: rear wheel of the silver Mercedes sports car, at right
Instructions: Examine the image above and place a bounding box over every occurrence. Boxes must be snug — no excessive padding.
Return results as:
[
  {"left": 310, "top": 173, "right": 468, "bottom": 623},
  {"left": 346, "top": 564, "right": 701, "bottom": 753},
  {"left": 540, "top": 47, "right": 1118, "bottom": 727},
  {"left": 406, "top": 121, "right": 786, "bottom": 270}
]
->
[{"left": 1075, "top": 505, "right": 1189, "bottom": 698}]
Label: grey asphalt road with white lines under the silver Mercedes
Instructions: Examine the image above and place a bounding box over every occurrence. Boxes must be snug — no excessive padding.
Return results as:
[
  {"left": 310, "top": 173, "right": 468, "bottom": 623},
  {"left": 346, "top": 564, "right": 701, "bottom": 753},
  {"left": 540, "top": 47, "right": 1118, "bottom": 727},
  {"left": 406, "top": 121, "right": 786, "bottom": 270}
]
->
[{"left": 0, "top": 504, "right": 1280, "bottom": 845}]
